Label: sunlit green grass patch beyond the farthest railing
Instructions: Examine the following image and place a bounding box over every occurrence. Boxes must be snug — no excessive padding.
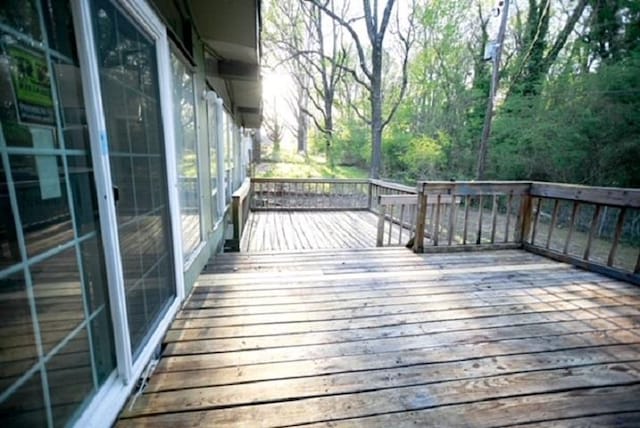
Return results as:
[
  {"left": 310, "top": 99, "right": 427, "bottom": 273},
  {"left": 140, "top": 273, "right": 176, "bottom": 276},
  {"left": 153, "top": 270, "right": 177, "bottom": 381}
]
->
[{"left": 254, "top": 150, "right": 368, "bottom": 178}]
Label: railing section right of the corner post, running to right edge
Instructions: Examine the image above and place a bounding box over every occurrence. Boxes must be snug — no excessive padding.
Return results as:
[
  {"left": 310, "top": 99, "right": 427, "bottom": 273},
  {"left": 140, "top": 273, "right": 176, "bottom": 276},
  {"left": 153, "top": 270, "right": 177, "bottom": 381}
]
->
[{"left": 523, "top": 182, "right": 640, "bottom": 283}]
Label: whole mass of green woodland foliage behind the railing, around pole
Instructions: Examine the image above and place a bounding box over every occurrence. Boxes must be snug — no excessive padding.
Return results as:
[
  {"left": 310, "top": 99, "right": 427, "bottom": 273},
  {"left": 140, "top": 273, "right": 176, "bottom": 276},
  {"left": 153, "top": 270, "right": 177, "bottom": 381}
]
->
[{"left": 262, "top": 0, "right": 640, "bottom": 187}]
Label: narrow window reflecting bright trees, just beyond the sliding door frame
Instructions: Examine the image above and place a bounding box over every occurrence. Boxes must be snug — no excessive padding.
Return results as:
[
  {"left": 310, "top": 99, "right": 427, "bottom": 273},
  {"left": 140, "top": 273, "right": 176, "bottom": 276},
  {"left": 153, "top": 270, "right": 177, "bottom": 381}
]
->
[{"left": 171, "top": 54, "right": 201, "bottom": 259}]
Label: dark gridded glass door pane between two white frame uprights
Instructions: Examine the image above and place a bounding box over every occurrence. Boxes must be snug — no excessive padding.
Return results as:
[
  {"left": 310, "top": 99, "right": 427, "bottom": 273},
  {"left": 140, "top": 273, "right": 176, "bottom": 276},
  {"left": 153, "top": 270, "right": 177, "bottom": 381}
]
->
[{"left": 93, "top": 0, "right": 175, "bottom": 356}]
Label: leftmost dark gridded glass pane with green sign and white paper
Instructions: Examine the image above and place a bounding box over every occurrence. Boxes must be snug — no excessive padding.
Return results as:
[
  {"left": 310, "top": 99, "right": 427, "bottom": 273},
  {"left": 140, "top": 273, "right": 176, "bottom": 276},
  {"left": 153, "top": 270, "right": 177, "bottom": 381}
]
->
[{"left": 0, "top": 0, "right": 115, "bottom": 426}]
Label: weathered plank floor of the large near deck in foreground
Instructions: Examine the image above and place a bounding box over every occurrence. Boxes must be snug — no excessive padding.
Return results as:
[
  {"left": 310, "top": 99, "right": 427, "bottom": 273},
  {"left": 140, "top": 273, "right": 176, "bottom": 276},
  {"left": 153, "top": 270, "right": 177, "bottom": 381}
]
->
[{"left": 118, "top": 248, "right": 640, "bottom": 428}]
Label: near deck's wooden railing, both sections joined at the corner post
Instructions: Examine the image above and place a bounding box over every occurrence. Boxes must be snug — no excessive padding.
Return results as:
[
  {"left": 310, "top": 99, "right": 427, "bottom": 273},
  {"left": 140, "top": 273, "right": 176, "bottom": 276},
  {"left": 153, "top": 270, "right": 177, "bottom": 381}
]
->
[{"left": 413, "top": 182, "right": 640, "bottom": 284}]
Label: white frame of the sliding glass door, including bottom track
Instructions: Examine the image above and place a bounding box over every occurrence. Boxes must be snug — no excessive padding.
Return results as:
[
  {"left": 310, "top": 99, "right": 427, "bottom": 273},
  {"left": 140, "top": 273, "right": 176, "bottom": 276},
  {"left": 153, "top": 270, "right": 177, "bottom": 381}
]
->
[{"left": 71, "top": 0, "right": 185, "bottom": 427}]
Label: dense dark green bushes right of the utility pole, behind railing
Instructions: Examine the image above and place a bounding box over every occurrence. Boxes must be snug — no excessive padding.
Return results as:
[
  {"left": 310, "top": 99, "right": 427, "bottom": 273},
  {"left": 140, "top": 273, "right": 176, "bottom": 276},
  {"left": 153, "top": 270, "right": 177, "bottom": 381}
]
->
[{"left": 490, "top": 50, "right": 640, "bottom": 187}]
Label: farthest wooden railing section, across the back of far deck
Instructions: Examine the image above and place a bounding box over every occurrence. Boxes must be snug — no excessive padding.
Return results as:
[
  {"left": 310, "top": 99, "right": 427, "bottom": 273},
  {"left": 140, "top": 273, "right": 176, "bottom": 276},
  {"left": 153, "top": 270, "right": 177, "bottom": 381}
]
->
[{"left": 251, "top": 178, "right": 369, "bottom": 211}]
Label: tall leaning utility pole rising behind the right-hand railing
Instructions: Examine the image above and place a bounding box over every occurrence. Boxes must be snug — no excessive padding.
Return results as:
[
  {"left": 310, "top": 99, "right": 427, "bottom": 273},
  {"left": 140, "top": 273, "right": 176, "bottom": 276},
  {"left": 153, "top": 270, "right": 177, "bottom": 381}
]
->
[{"left": 476, "top": 0, "right": 509, "bottom": 180}]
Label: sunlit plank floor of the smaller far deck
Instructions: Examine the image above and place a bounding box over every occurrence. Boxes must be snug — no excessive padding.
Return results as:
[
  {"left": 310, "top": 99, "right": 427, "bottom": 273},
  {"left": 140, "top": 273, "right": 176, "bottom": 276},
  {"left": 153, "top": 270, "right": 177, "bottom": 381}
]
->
[{"left": 240, "top": 210, "right": 410, "bottom": 252}]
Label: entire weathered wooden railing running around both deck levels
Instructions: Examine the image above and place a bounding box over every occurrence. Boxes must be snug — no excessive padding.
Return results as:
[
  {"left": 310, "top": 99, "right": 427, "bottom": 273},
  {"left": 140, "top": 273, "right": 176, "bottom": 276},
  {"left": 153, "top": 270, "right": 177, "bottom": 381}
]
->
[{"left": 241, "top": 178, "right": 640, "bottom": 283}]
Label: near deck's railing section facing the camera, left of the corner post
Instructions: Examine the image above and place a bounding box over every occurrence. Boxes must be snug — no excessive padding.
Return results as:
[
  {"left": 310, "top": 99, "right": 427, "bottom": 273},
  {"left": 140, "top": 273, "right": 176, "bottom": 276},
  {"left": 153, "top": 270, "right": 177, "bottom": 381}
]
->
[{"left": 414, "top": 182, "right": 530, "bottom": 252}]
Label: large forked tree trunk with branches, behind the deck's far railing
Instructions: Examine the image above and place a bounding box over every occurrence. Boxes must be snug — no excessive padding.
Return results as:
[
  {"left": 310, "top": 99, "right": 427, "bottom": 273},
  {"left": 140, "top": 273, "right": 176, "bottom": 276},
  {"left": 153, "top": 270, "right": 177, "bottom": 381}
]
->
[{"left": 305, "top": 0, "right": 415, "bottom": 178}]
